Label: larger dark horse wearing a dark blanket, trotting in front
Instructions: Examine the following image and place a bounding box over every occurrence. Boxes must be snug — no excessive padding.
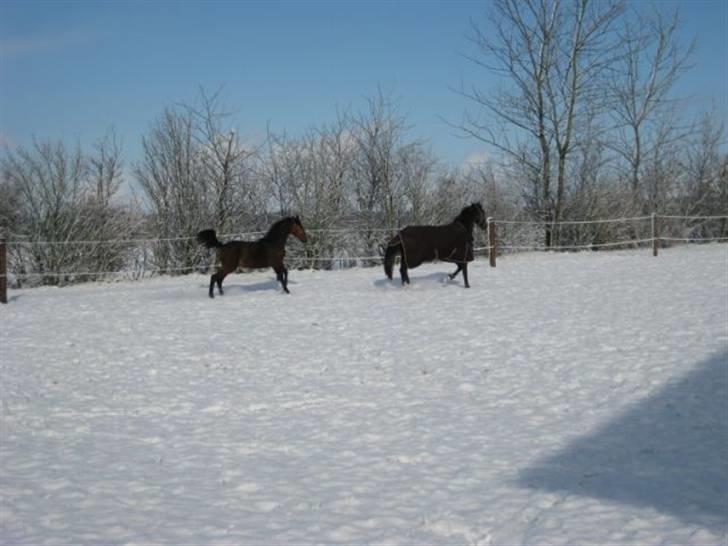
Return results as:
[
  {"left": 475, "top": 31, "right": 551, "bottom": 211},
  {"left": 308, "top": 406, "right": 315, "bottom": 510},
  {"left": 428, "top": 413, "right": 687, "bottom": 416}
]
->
[{"left": 384, "top": 203, "right": 487, "bottom": 288}]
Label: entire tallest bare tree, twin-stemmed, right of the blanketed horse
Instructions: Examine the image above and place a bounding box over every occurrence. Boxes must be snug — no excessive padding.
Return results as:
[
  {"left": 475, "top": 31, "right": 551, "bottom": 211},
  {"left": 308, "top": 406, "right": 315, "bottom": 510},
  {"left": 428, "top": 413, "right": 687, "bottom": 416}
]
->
[{"left": 462, "top": 0, "right": 623, "bottom": 246}]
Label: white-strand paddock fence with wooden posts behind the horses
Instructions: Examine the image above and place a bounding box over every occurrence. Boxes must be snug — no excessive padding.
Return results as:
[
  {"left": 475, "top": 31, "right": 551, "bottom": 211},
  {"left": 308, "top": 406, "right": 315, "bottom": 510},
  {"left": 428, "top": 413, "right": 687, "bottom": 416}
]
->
[{"left": 0, "top": 214, "right": 728, "bottom": 303}]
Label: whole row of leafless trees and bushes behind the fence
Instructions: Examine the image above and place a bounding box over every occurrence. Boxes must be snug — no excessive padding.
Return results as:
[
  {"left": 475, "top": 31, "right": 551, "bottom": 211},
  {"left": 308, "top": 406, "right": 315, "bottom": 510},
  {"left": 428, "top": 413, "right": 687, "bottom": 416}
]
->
[{"left": 0, "top": 0, "right": 728, "bottom": 284}]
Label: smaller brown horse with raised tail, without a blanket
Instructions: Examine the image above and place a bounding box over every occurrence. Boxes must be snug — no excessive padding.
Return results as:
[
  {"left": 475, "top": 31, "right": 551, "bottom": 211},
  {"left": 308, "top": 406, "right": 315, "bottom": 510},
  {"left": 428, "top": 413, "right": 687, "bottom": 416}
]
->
[{"left": 197, "top": 216, "right": 306, "bottom": 298}]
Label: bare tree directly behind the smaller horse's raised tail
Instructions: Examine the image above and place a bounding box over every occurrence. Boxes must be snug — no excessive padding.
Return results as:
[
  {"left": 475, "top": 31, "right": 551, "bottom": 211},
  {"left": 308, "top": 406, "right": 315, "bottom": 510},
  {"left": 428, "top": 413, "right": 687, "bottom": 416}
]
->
[{"left": 134, "top": 90, "right": 259, "bottom": 273}]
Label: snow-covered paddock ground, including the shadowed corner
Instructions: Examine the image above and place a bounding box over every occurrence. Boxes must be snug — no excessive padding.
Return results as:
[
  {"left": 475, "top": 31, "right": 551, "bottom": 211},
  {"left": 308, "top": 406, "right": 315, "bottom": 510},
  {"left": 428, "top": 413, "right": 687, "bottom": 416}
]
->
[{"left": 0, "top": 245, "right": 728, "bottom": 545}]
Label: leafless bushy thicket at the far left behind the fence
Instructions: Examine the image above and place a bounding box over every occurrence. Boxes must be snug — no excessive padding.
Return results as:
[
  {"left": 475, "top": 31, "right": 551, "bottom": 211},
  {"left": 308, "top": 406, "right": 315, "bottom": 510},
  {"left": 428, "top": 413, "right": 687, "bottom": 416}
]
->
[{"left": 0, "top": 134, "right": 139, "bottom": 284}]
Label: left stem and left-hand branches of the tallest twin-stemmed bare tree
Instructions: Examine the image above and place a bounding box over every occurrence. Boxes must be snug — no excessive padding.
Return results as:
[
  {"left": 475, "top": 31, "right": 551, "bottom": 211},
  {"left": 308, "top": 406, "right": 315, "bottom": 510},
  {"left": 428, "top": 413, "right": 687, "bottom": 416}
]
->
[{"left": 462, "top": 0, "right": 559, "bottom": 240}]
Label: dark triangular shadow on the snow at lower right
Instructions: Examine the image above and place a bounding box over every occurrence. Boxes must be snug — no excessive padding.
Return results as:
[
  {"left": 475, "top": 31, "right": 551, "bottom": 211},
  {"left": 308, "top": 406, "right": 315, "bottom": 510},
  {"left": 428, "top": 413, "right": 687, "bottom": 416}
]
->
[{"left": 518, "top": 352, "right": 728, "bottom": 532}]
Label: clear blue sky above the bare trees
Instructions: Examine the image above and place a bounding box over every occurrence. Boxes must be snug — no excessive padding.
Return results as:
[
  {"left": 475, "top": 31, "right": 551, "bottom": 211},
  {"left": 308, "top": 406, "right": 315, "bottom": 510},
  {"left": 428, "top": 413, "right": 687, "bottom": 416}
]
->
[{"left": 0, "top": 0, "right": 728, "bottom": 170}]
